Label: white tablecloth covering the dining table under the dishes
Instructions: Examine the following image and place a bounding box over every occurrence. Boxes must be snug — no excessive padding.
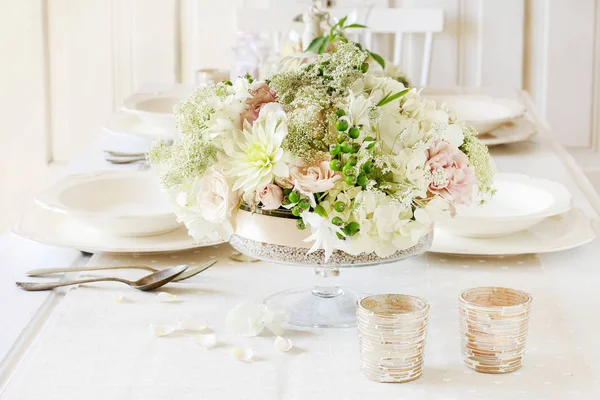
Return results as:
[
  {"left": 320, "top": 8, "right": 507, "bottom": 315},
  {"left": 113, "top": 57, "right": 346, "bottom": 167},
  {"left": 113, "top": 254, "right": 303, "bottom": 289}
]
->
[{"left": 2, "top": 89, "right": 600, "bottom": 400}]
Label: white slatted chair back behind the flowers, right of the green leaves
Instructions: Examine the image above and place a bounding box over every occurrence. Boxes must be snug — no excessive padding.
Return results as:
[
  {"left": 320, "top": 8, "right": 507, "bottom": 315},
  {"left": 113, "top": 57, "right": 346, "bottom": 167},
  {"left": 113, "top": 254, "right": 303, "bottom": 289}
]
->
[{"left": 364, "top": 8, "right": 444, "bottom": 87}]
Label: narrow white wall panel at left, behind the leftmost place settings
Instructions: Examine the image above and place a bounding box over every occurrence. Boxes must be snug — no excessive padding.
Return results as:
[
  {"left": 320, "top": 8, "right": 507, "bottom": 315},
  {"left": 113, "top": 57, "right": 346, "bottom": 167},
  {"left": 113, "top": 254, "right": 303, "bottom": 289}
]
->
[{"left": 48, "top": 0, "right": 114, "bottom": 161}]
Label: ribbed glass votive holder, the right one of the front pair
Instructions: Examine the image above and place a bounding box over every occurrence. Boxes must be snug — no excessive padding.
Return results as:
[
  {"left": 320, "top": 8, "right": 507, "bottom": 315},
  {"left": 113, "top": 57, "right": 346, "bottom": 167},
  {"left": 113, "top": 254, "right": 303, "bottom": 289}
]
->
[{"left": 459, "top": 287, "right": 532, "bottom": 374}]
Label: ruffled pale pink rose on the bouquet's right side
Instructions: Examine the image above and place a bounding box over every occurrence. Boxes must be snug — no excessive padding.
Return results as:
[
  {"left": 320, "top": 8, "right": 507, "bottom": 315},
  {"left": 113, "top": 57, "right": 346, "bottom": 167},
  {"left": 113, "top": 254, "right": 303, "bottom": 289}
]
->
[{"left": 426, "top": 140, "right": 475, "bottom": 204}]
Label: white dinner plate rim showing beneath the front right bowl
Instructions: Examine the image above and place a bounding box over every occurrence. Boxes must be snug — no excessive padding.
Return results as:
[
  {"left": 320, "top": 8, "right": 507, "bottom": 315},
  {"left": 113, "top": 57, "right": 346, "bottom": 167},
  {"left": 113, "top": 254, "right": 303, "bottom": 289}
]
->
[{"left": 429, "top": 208, "right": 596, "bottom": 256}]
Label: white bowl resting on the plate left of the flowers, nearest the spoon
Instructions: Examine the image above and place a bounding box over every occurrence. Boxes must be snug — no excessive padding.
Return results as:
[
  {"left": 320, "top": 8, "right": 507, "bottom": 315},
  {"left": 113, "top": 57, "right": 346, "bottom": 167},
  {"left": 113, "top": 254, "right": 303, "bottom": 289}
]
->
[{"left": 35, "top": 171, "right": 180, "bottom": 236}]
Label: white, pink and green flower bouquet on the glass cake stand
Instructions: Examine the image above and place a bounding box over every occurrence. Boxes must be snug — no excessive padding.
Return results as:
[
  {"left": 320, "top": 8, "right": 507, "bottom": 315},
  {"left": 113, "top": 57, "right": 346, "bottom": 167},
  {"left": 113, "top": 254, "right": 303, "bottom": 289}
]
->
[{"left": 149, "top": 43, "right": 492, "bottom": 258}]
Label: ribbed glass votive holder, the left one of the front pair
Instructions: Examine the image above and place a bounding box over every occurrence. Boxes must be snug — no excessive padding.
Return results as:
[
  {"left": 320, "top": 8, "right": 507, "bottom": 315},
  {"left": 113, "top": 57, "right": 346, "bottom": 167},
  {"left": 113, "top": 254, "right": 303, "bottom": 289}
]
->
[{"left": 356, "top": 294, "right": 429, "bottom": 383}]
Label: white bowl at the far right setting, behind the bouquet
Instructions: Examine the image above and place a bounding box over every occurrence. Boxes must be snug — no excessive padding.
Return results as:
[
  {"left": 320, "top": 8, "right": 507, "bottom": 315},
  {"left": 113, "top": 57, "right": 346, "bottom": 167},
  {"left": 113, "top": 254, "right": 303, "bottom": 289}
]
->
[{"left": 426, "top": 94, "right": 525, "bottom": 134}]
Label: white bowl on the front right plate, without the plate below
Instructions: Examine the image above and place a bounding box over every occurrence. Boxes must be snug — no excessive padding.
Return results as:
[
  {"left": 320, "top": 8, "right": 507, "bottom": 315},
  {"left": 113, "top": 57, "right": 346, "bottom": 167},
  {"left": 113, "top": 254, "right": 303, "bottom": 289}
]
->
[{"left": 437, "top": 173, "right": 571, "bottom": 237}]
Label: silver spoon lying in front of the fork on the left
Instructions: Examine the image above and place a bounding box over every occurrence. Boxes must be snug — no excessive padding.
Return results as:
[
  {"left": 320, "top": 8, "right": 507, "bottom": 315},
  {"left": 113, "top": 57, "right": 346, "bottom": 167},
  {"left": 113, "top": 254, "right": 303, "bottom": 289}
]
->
[{"left": 17, "top": 264, "right": 188, "bottom": 291}]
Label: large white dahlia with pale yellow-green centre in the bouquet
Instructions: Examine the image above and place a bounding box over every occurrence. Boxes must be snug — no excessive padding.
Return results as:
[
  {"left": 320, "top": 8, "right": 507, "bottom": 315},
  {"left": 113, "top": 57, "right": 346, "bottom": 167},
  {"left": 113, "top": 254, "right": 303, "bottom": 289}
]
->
[{"left": 223, "top": 103, "right": 289, "bottom": 192}]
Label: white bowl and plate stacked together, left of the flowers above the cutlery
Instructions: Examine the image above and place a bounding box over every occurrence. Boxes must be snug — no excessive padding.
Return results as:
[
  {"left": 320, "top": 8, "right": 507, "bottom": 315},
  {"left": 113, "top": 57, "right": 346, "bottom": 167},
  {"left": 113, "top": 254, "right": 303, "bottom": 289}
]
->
[{"left": 13, "top": 171, "right": 222, "bottom": 253}]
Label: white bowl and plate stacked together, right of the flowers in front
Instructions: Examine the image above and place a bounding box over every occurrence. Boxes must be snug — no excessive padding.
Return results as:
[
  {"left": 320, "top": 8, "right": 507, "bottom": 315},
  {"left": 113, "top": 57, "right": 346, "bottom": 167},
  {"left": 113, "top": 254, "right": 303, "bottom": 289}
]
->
[{"left": 429, "top": 173, "right": 595, "bottom": 255}]
